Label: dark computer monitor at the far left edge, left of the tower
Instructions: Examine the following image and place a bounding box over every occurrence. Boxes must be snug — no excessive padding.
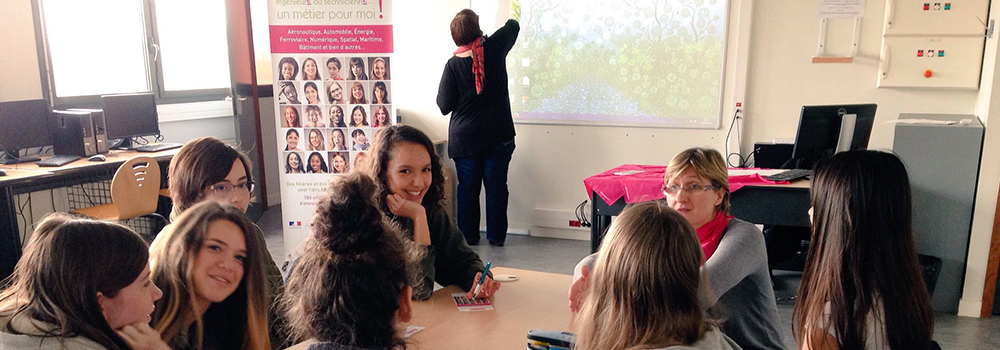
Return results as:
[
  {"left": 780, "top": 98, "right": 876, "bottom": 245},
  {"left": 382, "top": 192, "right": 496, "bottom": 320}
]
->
[{"left": 0, "top": 100, "right": 52, "bottom": 164}]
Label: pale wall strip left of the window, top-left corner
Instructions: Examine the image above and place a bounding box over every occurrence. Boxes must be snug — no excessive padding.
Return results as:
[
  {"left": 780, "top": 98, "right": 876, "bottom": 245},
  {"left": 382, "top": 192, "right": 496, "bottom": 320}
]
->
[{"left": 0, "top": 1, "right": 42, "bottom": 101}]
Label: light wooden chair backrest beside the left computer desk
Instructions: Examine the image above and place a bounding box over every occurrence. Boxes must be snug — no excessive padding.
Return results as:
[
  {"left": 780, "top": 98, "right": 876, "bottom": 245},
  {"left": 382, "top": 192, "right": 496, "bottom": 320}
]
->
[{"left": 111, "top": 156, "right": 160, "bottom": 220}]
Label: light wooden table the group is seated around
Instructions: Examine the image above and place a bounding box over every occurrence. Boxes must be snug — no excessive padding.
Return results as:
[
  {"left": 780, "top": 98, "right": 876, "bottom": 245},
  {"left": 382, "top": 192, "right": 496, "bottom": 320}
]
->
[{"left": 289, "top": 267, "right": 573, "bottom": 350}]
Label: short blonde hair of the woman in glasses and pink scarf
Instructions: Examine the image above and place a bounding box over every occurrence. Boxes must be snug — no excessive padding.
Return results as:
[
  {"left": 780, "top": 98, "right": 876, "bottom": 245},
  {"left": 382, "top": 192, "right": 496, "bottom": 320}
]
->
[{"left": 663, "top": 147, "right": 729, "bottom": 215}]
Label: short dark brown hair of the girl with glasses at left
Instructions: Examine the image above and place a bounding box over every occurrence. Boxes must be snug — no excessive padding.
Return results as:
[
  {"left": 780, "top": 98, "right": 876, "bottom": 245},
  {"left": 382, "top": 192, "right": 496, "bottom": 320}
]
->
[{"left": 167, "top": 136, "right": 253, "bottom": 218}]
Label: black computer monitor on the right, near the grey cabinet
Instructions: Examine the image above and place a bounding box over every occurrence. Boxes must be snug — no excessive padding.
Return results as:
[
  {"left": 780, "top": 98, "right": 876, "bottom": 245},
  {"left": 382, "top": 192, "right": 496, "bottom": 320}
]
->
[{"left": 785, "top": 104, "right": 876, "bottom": 169}]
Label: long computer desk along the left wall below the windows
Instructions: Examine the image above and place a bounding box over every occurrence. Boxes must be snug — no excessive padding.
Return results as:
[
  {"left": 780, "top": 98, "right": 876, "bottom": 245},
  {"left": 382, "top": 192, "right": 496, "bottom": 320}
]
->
[{"left": 0, "top": 149, "right": 179, "bottom": 278}]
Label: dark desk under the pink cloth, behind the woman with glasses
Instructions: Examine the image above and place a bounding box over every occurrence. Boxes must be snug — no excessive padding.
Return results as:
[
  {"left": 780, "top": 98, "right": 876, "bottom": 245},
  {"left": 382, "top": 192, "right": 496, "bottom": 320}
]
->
[{"left": 590, "top": 179, "right": 810, "bottom": 252}]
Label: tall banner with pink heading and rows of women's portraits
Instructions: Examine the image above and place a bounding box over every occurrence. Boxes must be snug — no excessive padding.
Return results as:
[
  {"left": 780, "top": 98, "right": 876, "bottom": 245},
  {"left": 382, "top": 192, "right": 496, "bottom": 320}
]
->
[{"left": 261, "top": 0, "right": 396, "bottom": 258}]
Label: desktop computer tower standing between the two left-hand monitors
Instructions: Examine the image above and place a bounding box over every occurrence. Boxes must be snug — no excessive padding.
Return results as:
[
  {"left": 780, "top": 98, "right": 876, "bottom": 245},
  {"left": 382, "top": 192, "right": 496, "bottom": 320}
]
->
[{"left": 49, "top": 110, "right": 97, "bottom": 157}]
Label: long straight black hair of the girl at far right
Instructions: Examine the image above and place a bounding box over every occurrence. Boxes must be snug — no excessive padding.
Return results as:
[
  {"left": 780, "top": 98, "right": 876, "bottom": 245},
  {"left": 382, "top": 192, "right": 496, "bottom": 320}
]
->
[{"left": 794, "top": 151, "right": 934, "bottom": 349}]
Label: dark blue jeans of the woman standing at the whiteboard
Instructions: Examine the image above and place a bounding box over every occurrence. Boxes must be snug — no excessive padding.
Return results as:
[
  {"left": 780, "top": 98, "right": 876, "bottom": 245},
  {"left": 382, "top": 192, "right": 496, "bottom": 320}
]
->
[{"left": 455, "top": 140, "right": 514, "bottom": 244}]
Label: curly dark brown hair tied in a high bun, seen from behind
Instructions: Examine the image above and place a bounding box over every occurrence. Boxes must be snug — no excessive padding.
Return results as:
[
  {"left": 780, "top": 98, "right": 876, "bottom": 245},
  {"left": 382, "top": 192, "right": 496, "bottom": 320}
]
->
[{"left": 280, "top": 172, "right": 419, "bottom": 349}]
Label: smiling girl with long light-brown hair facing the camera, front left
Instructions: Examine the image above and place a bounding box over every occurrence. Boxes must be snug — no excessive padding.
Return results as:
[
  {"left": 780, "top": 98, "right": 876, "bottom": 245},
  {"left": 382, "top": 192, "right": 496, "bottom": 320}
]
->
[{"left": 149, "top": 201, "right": 272, "bottom": 350}]
